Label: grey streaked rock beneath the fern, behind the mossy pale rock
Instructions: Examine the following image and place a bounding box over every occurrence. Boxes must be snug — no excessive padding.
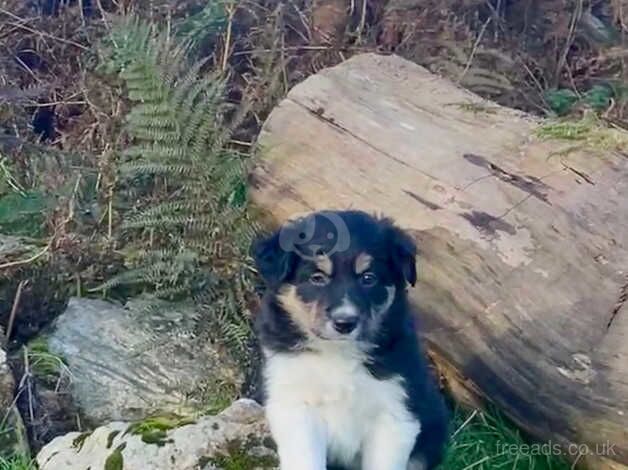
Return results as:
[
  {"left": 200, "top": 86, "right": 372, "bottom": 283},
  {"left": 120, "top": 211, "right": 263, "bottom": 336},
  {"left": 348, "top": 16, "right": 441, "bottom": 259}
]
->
[{"left": 48, "top": 298, "right": 243, "bottom": 426}]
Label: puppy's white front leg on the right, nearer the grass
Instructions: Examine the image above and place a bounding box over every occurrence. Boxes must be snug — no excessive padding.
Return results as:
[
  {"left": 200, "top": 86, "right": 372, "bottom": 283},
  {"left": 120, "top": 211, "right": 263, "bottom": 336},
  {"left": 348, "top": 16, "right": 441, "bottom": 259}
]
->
[{"left": 362, "top": 414, "right": 421, "bottom": 470}]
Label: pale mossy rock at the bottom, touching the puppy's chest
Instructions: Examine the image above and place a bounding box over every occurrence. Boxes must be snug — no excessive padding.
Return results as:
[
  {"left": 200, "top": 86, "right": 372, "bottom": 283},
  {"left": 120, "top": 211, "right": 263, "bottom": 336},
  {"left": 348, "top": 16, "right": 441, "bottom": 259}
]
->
[{"left": 37, "top": 399, "right": 277, "bottom": 470}]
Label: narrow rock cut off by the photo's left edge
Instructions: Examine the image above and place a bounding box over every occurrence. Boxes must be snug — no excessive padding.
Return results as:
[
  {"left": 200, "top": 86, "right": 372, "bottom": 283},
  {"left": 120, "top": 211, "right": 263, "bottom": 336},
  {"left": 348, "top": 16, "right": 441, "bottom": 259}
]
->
[{"left": 0, "top": 347, "right": 30, "bottom": 457}]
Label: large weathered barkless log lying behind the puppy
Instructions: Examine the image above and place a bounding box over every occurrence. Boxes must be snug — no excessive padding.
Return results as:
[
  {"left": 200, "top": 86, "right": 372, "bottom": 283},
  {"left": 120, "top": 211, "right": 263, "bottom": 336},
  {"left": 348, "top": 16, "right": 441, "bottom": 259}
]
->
[{"left": 251, "top": 54, "right": 628, "bottom": 468}]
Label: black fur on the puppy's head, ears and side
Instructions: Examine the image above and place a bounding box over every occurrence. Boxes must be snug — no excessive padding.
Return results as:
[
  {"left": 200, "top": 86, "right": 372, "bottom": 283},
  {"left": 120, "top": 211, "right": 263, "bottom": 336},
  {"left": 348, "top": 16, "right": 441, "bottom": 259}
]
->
[{"left": 253, "top": 211, "right": 449, "bottom": 469}]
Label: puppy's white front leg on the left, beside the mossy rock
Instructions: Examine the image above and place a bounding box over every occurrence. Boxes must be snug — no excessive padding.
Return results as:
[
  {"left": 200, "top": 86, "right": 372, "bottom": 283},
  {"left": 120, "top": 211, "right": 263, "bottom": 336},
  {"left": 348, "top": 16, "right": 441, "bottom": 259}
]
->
[{"left": 266, "top": 404, "right": 327, "bottom": 470}]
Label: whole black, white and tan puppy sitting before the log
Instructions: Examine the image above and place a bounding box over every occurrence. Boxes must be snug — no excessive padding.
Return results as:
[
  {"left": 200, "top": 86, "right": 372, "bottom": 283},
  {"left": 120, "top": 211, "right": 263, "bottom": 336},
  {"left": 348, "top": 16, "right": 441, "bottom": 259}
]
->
[{"left": 254, "top": 211, "right": 448, "bottom": 470}]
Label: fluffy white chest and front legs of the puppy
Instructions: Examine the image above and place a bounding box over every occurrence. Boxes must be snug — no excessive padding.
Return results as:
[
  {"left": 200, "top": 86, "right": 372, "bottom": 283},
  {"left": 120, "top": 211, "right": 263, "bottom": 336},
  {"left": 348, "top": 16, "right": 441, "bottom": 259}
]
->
[{"left": 265, "top": 343, "right": 420, "bottom": 470}]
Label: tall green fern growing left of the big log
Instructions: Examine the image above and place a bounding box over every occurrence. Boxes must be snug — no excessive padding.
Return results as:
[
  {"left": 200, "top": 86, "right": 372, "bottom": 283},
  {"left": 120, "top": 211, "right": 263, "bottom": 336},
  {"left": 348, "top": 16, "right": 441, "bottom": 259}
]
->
[{"left": 92, "top": 19, "right": 255, "bottom": 368}]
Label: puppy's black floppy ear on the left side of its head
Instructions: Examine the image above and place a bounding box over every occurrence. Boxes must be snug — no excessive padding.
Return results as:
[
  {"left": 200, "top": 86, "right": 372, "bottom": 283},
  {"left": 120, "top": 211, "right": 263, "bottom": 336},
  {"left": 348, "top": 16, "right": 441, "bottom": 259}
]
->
[{"left": 251, "top": 232, "right": 294, "bottom": 287}]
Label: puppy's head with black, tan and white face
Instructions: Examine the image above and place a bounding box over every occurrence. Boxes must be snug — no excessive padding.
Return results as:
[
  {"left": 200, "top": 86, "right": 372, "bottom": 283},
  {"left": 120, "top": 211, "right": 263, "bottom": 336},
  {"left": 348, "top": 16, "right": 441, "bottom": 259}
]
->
[{"left": 254, "top": 211, "right": 416, "bottom": 341}]
